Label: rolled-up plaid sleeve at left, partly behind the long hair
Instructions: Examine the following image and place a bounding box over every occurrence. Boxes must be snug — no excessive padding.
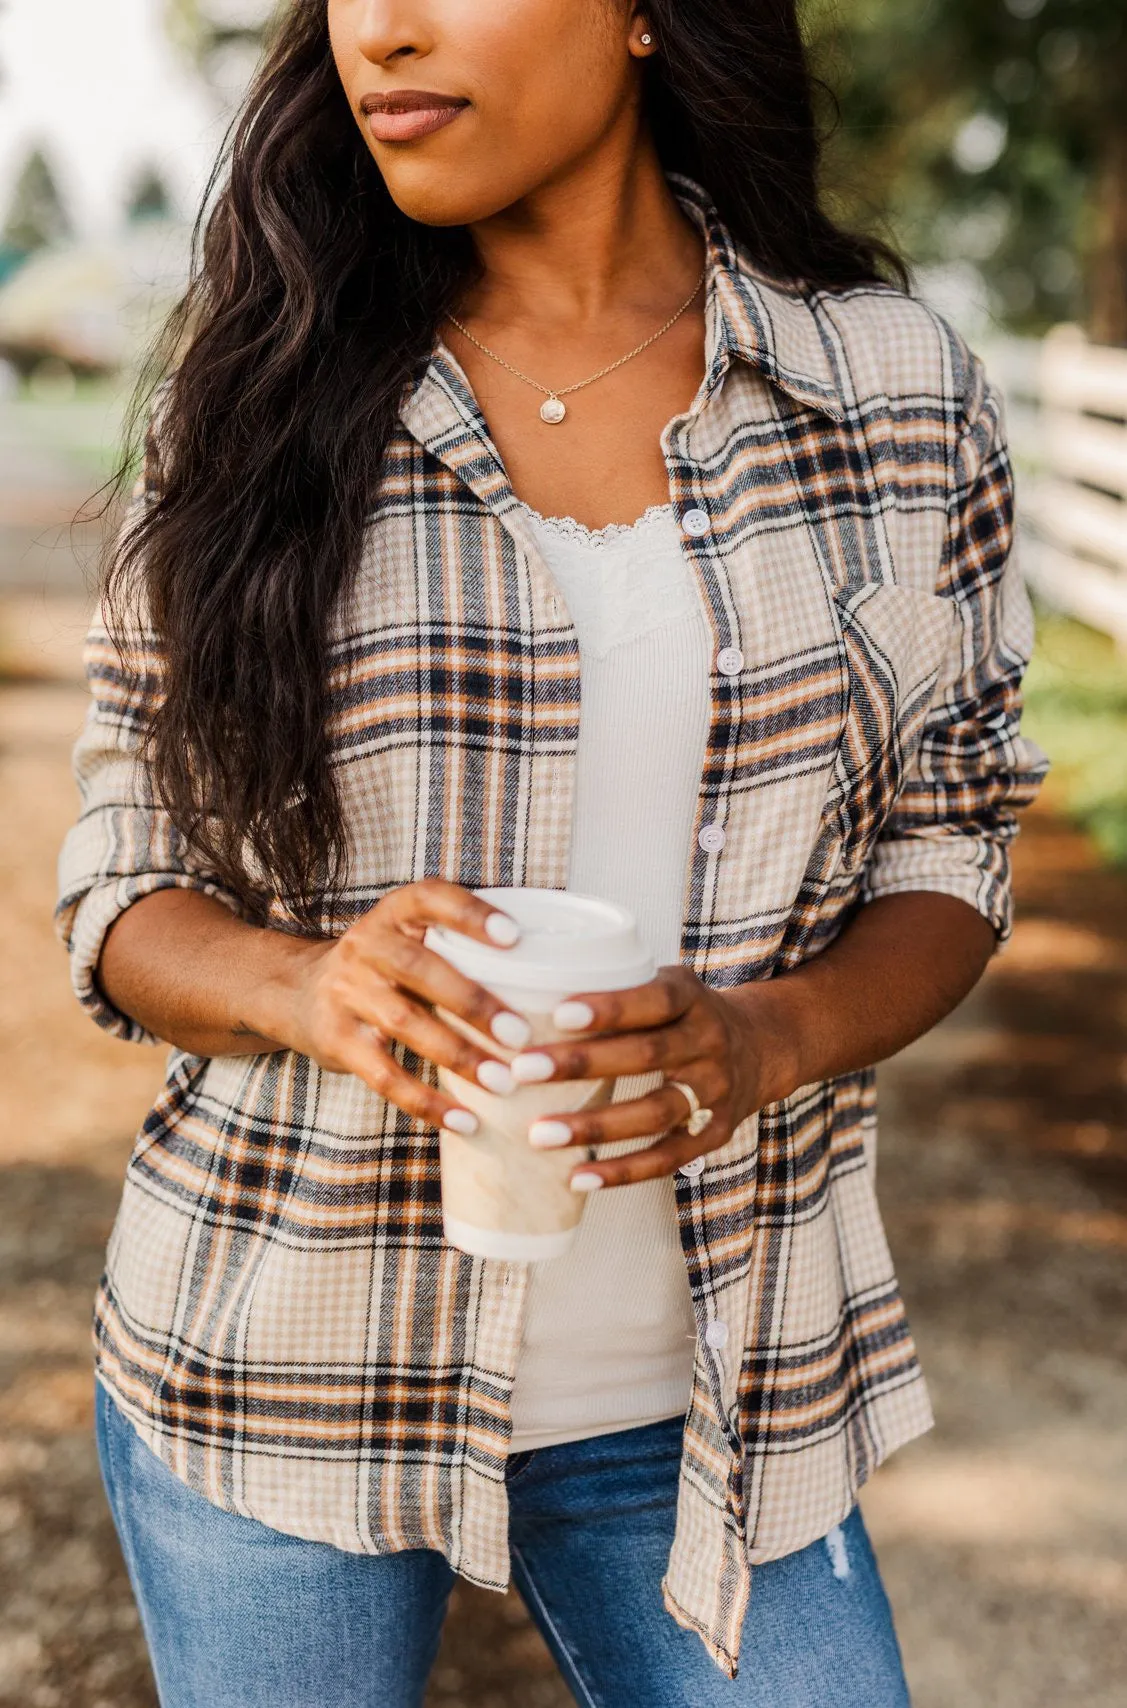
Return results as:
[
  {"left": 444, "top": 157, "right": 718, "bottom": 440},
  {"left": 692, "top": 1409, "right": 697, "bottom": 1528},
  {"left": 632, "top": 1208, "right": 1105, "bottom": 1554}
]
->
[{"left": 55, "top": 447, "right": 241, "bottom": 1044}]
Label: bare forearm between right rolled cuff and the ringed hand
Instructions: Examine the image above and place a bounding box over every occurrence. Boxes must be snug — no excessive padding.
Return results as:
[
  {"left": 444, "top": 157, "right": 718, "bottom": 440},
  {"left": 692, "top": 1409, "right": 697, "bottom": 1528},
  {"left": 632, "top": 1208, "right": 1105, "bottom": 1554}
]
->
[{"left": 731, "top": 892, "right": 996, "bottom": 1097}]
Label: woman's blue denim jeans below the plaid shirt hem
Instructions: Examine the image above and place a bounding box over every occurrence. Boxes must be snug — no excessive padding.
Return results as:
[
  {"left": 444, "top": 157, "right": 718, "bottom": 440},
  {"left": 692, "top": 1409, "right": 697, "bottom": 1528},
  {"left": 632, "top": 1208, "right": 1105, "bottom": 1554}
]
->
[{"left": 97, "top": 1385, "right": 908, "bottom": 1708}]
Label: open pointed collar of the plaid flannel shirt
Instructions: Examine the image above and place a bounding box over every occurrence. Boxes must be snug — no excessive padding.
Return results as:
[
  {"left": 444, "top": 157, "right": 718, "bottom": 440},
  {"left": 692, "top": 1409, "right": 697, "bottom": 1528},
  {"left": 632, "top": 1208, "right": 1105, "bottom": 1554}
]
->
[{"left": 400, "top": 173, "right": 845, "bottom": 461}]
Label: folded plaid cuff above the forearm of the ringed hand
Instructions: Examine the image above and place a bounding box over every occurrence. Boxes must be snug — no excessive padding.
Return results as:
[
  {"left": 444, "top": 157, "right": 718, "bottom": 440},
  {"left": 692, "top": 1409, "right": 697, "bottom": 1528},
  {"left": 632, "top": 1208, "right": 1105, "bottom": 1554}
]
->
[{"left": 862, "top": 830, "right": 1014, "bottom": 948}]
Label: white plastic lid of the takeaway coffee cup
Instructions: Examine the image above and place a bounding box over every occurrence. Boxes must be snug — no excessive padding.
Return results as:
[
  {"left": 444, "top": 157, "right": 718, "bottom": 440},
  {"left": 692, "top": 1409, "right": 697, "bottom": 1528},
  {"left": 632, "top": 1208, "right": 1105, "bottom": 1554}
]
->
[{"left": 425, "top": 888, "right": 656, "bottom": 996}]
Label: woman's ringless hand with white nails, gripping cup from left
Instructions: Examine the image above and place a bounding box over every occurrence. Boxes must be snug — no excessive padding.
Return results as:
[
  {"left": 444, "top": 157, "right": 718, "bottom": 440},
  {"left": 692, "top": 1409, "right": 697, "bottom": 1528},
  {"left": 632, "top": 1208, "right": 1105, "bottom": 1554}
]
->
[{"left": 285, "top": 878, "right": 531, "bottom": 1134}]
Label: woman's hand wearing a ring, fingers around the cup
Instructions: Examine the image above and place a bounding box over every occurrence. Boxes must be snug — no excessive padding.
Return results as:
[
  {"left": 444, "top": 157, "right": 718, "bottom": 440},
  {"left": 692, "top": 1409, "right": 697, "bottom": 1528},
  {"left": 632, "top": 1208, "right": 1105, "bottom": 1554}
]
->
[{"left": 511, "top": 967, "right": 797, "bottom": 1190}]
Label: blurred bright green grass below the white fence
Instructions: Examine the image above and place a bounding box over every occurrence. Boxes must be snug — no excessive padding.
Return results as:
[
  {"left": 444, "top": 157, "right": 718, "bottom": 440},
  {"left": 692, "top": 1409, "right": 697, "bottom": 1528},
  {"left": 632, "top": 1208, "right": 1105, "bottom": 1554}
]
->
[{"left": 1023, "top": 611, "right": 1127, "bottom": 866}]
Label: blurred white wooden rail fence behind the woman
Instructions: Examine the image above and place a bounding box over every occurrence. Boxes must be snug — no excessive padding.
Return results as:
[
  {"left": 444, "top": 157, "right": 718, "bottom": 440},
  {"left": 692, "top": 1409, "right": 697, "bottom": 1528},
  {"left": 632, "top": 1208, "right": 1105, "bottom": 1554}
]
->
[{"left": 984, "top": 326, "right": 1127, "bottom": 651}]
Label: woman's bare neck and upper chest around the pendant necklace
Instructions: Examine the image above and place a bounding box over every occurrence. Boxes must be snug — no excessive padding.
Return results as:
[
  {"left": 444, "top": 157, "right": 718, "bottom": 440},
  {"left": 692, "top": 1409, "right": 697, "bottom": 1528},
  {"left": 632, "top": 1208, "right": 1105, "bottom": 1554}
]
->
[{"left": 447, "top": 134, "right": 705, "bottom": 528}]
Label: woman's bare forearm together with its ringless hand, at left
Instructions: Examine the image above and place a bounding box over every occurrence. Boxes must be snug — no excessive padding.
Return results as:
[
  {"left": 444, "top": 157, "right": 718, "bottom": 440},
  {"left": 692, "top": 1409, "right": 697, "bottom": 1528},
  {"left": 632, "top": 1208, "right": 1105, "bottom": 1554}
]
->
[{"left": 91, "top": 878, "right": 529, "bottom": 1134}]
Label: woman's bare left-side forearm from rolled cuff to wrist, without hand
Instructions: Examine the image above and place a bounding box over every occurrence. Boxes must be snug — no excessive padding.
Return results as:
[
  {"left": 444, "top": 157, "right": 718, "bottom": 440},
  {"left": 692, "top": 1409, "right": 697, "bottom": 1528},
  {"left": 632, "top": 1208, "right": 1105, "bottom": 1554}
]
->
[{"left": 97, "top": 890, "right": 328, "bottom": 1056}]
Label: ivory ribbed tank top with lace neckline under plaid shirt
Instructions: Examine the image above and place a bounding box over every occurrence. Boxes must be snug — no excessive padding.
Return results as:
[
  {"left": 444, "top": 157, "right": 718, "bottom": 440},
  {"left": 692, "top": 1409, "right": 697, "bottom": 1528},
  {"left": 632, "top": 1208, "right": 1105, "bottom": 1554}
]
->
[{"left": 511, "top": 504, "right": 710, "bottom": 1452}]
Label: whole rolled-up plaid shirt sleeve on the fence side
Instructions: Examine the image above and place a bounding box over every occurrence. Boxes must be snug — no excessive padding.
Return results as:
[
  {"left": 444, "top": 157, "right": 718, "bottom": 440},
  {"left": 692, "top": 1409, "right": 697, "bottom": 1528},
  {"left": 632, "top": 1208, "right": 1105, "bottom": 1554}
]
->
[{"left": 862, "top": 362, "right": 1048, "bottom": 945}]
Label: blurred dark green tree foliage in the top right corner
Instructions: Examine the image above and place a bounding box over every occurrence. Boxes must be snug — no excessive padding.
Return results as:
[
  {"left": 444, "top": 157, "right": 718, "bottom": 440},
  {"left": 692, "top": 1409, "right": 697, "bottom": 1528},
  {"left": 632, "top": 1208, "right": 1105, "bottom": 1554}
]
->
[{"left": 804, "top": 0, "right": 1127, "bottom": 343}]
